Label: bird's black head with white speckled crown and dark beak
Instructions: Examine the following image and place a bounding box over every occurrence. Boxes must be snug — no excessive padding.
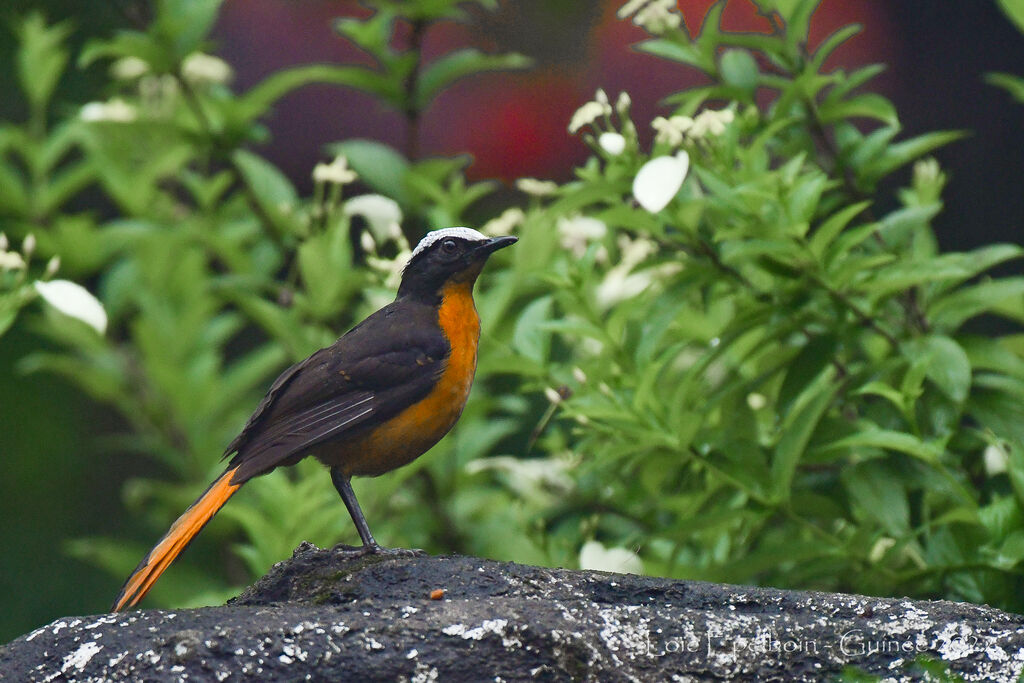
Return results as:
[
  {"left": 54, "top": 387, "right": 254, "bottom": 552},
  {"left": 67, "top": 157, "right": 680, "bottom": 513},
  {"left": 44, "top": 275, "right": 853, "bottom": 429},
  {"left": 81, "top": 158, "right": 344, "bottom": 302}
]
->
[{"left": 398, "top": 227, "right": 517, "bottom": 298}]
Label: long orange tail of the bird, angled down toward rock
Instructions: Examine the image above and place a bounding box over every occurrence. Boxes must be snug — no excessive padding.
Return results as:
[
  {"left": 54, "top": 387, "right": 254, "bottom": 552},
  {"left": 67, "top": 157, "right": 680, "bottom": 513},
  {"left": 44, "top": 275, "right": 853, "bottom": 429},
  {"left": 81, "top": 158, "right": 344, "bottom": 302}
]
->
[{"left": 112, "top": 468, "right": 242, "bottom": 611}]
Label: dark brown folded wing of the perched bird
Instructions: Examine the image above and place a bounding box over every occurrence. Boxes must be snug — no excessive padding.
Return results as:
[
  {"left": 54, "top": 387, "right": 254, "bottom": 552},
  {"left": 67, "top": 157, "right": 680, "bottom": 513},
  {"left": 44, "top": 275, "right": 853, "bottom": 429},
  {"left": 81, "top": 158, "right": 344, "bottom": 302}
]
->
[{"left": 225, "top": 302, "right": 450, "bottom": 483}]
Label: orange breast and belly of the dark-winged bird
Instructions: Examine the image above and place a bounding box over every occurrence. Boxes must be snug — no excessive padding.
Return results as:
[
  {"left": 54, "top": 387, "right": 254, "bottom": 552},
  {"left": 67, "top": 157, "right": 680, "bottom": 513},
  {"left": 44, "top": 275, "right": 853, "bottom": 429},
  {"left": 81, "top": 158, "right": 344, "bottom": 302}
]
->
[{"left": 341, "top": 283, "right": 480, "bottom": 476}]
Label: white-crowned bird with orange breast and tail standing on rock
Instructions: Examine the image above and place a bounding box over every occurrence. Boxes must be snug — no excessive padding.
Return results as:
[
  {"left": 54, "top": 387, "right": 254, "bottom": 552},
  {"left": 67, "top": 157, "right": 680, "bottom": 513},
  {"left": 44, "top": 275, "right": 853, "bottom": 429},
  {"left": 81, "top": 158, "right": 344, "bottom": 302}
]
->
[{"left": 112, "top": 227, "right": 517, "bottom": 611}]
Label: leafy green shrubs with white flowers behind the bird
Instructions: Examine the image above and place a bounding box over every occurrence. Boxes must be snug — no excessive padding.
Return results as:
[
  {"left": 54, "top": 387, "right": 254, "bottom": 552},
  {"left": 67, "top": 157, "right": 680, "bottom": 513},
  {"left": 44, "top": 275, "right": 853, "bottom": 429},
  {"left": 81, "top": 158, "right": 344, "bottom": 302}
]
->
[{"left": 0, "top": 0, "right": 1024, "bottom": 634}]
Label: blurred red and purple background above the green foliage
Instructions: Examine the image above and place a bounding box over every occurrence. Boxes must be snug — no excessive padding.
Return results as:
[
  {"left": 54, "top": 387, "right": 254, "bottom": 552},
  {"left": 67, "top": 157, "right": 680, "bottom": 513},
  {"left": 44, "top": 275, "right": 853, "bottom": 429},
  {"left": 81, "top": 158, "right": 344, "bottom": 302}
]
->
[{"left": 216, "top": 0, "right": 894, "bottom": 180}]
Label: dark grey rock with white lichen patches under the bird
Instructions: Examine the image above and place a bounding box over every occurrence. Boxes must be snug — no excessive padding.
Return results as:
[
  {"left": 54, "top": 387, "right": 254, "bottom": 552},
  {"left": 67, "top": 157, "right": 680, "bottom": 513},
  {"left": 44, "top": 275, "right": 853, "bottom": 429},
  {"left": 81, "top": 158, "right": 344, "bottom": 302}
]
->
[{"left": 0, "top": 544, "right": 1024, "bottom": 682}]
